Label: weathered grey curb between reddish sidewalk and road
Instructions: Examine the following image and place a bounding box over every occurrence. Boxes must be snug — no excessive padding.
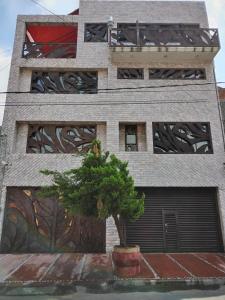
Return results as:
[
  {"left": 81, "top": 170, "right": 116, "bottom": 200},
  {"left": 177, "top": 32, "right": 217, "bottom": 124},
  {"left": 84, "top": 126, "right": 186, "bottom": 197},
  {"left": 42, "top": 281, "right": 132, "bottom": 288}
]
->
[{"left": 0, "top": 278, "right": 225, "bottom": 296}]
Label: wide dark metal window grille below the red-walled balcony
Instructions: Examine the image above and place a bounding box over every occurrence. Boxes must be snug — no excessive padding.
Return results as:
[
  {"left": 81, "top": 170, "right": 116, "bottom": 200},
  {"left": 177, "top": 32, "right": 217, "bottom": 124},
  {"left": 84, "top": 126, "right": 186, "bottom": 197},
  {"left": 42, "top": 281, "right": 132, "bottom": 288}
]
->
[{"left": 31, "top": 71, "right": 98, "bottom": 94}]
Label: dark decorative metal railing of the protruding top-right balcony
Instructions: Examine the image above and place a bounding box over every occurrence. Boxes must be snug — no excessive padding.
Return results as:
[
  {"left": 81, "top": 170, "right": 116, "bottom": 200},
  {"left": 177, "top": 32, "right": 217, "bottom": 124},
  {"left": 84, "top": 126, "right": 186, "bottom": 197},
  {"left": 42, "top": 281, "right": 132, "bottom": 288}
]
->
[{"left": 109, "top": 24, "right": 220, "bottom": 48}]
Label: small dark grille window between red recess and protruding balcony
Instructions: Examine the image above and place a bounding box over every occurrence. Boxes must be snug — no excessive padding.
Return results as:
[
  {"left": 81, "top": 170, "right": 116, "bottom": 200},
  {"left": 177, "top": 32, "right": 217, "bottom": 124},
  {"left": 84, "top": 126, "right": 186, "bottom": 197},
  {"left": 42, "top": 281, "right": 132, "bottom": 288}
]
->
[{"left": 84, "top": 23, "right": 108, "bottom": 42}]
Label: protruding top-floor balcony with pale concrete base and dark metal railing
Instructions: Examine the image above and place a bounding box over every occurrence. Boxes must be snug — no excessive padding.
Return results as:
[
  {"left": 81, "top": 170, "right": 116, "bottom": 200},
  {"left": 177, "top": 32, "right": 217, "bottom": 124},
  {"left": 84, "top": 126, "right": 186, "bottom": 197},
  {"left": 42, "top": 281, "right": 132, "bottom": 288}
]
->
[{"left": 109, "top": 23, "right": 220, "bottom": 62}]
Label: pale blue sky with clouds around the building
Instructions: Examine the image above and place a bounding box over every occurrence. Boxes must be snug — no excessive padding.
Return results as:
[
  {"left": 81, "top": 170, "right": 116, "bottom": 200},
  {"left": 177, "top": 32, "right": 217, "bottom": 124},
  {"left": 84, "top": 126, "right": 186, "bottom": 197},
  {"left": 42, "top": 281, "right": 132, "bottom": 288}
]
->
[{"left": 0, "top": 0, "right": 225, "bottom": 125}]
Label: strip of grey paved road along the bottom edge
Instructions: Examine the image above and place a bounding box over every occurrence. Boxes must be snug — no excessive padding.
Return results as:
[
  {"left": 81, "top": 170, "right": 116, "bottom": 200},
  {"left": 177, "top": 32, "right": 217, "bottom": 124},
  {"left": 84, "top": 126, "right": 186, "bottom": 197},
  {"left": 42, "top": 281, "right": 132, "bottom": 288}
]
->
[{"left": 0, "top": 287, "right": 225, "bottom": 300}]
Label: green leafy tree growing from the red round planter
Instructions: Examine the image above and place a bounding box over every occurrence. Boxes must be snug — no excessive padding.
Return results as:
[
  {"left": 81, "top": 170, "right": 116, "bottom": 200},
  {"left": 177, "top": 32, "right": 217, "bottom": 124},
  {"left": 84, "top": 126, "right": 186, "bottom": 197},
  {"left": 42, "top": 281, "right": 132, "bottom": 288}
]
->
[{"left": 40, "top": 140, "right": 144, "bottom": 247}]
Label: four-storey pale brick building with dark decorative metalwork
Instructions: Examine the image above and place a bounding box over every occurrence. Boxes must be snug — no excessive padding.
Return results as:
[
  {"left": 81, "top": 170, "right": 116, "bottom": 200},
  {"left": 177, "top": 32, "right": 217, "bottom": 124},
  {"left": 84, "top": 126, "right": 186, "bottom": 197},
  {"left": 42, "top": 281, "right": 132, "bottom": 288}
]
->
[{"left": 0, "top": 0, "right": 225, "bottom": 252}]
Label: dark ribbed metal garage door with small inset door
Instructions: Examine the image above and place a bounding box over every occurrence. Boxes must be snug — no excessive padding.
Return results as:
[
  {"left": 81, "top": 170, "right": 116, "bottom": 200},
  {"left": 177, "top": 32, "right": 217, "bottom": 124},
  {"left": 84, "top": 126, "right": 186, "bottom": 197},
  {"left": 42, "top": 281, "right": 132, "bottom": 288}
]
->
[{"left": 126, "top": 188, "right": 223, "bottom": 252}]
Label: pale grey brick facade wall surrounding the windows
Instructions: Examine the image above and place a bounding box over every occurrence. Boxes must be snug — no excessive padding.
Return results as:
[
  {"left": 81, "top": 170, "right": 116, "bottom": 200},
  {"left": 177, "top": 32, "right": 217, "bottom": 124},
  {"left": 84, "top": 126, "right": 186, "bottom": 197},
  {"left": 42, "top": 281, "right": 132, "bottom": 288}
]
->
[{"left": 0, "top": 0, "right": 225, "bottom": 249}]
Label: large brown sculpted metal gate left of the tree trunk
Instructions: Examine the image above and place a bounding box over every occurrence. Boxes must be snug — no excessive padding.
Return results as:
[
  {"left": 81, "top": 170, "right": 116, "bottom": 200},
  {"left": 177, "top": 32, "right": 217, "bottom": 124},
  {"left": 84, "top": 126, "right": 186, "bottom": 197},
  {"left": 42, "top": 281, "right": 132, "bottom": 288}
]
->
[{"left": 1, "top": 187, "right": 105, "bottom": 253}]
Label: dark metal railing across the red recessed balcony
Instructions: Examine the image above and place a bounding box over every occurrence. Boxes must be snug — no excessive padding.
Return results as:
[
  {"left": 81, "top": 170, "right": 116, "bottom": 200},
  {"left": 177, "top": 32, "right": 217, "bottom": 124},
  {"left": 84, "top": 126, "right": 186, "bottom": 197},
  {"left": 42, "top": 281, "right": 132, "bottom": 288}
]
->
[{"left": 22, "top": 42, "right": 77, "bottom": 58}]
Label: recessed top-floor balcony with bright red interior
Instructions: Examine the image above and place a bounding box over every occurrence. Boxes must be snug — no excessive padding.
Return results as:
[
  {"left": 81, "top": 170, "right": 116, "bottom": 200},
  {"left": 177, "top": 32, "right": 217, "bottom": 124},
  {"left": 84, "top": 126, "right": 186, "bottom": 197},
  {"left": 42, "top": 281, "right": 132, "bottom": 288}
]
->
[{"left": 22, "top": 23, "right": 77, "bottom": 59}]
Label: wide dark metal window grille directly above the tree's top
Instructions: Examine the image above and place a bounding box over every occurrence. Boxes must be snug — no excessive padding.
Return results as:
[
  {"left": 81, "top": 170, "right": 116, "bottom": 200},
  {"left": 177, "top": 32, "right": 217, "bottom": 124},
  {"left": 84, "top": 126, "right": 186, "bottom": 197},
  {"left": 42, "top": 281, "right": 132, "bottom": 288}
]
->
[{"left": 27, "top": 125, "right": 96, "bottom": 153}]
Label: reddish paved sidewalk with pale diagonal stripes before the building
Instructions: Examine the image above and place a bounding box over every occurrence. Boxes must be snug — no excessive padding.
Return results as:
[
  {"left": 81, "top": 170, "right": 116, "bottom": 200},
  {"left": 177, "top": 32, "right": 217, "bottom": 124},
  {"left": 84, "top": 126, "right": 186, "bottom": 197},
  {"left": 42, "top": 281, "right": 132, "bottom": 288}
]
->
[{"left": 0, "top": 253, "right": 225, "bottom": 286}]
